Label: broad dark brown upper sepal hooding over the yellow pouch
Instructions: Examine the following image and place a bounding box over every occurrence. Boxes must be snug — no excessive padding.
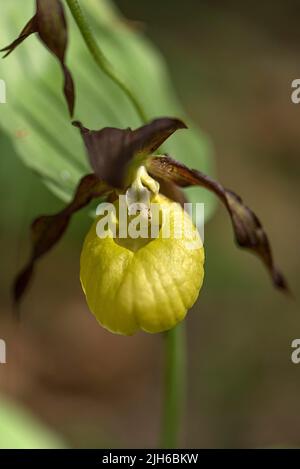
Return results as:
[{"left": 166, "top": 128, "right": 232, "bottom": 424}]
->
[{"left": 73, "top": 118, "right": 185, "bottom": 188}]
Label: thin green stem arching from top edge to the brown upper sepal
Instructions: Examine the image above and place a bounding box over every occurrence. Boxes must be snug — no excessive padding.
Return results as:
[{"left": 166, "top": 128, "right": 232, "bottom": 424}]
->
[{"left": 66, "top": 0, "right": 147, "bottom": 123}]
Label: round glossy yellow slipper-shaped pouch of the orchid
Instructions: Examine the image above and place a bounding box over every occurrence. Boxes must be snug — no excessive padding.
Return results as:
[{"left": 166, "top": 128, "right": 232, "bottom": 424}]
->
[{"left": 80, "top": 176, "right": 204, "bottom": 335}]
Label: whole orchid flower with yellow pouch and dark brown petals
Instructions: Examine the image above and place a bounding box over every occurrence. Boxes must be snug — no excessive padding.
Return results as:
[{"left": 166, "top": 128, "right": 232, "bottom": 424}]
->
[{"left": 12, "top": 117, "right": 289, "bottom": 314}]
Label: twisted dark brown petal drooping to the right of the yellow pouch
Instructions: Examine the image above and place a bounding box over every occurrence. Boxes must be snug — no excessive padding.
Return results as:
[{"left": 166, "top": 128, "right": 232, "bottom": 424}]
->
[{"left": 146, "top": 157, "right": 289, "bottom": 292}]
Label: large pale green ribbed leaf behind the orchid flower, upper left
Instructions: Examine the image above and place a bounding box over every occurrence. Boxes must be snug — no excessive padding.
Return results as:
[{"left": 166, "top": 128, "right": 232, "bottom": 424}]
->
[{"left": 0, "top": 0, "right": 214, "bottom": 216}]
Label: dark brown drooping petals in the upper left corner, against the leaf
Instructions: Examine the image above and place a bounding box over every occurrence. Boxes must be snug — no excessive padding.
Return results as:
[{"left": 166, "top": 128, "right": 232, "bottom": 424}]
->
[{"left": 0, "top": 0, "right": 75, "bottom": 116}]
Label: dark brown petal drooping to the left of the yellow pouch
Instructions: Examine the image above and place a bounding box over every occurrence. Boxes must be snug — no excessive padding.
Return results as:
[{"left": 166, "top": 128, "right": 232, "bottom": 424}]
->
[{"left": 13, "top": 174, "right": 111, "bottom": 305}]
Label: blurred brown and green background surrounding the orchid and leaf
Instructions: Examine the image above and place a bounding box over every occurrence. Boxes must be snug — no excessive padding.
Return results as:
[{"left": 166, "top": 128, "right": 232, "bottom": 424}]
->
[{"left": 0, "top": 0, "right": 300, "bottom": 448}]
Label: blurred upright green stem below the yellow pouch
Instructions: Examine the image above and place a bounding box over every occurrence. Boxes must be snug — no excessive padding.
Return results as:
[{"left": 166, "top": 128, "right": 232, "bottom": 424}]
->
[{"left": 161, "top": 323, "right": 186, "bottom": 449}]
